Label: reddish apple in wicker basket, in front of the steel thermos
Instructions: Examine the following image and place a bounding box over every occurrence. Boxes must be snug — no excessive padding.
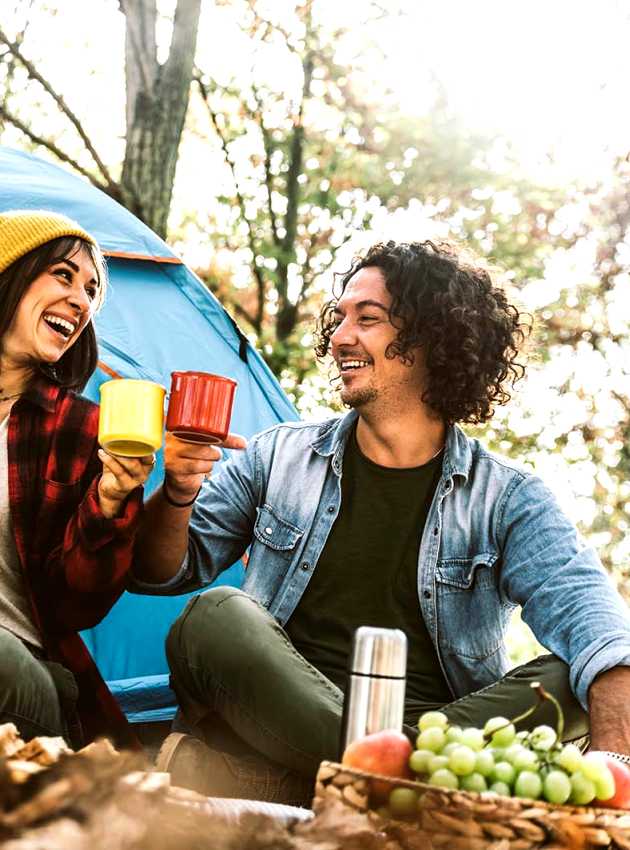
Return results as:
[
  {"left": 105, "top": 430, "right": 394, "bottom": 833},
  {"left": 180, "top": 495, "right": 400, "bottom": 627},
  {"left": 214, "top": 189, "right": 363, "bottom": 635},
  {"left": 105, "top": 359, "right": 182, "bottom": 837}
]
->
[{"left": 341, "top": 729, "right": 413, "bottom": 796}]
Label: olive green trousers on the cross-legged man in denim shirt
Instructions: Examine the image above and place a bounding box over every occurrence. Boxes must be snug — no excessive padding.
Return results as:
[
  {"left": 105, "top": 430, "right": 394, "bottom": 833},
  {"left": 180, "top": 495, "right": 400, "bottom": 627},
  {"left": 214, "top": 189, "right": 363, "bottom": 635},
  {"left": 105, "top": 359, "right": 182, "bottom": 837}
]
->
[{"left": 166, "top": 587, "right": 588, "bottom": 802}]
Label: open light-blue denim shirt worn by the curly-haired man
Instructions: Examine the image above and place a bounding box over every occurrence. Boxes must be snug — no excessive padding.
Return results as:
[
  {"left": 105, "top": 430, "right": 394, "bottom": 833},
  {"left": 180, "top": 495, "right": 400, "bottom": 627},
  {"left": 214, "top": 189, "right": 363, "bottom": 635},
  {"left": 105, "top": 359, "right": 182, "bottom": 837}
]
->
[{"left": 138, "top": 411, "right": 630, "bottom": 708}]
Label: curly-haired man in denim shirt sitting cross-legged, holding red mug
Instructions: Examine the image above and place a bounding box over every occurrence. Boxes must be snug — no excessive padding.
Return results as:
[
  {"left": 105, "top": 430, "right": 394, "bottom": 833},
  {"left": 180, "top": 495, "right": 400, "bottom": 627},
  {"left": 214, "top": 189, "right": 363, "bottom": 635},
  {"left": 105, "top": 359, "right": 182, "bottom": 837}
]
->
[{"left": 136, "top": 242, "right": 630, "bottom": 802}]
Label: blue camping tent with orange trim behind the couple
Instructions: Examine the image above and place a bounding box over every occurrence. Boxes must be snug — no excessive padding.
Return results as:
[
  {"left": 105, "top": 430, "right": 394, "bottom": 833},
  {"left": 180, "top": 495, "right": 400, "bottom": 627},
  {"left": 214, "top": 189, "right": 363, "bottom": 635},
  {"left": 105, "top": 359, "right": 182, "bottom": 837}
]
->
[{"left": 0, "top": 148, "right": 297, "bottom": 722}]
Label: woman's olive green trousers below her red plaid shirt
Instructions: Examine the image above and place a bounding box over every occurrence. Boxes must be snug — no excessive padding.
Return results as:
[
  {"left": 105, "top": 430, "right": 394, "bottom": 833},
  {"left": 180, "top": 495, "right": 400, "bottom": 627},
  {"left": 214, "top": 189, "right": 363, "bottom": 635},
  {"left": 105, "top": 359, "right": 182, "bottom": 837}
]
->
[{"left": 0, "top": 627, "right": 78, "bottom": 741}]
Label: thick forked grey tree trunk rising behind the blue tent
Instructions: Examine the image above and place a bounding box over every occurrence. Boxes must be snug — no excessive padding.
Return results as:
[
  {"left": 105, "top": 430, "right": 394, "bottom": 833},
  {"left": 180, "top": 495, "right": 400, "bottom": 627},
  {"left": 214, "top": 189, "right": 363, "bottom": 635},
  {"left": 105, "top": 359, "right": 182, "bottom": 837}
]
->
[{"left": 120, "top": 0, "right": 201, "bottom": 238}]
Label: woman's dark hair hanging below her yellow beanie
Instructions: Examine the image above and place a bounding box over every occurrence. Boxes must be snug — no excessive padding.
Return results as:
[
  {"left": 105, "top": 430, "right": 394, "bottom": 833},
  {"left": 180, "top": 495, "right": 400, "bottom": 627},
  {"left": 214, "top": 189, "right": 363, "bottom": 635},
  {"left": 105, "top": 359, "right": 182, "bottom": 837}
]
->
[{"left": 0, "top": 236, "right": 106, "bottom": 392}]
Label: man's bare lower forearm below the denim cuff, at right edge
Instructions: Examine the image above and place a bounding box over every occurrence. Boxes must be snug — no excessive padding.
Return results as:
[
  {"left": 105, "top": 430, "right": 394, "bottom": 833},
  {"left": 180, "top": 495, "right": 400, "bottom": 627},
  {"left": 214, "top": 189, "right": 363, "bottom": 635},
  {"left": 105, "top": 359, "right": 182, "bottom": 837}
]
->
[{"left": 588, "top": 667, "right": 630, "bottom": 755}]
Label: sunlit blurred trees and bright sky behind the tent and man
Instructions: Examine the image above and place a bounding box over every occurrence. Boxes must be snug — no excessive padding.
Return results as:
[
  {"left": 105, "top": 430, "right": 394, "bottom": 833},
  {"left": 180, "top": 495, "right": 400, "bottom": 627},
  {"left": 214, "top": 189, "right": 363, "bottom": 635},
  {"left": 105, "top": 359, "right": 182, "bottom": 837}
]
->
[{"left": 0, "top": 0, "right": 630, "bottom": 648}]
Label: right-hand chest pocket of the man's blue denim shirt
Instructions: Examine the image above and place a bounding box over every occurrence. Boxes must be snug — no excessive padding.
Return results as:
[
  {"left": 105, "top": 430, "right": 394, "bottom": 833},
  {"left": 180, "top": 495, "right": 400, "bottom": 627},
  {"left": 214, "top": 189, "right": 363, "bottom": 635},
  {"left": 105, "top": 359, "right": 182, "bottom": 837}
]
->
[{"left": 435, "top": 552, "right": 504, "bottom": 660}]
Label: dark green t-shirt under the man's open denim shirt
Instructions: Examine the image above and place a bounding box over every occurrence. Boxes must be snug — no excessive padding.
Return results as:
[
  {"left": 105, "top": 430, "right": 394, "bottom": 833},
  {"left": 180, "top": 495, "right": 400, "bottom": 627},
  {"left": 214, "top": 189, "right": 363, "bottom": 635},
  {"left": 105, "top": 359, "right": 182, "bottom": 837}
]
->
[{"left": 285, "top": 424, "right": 452, "bottom": 708}]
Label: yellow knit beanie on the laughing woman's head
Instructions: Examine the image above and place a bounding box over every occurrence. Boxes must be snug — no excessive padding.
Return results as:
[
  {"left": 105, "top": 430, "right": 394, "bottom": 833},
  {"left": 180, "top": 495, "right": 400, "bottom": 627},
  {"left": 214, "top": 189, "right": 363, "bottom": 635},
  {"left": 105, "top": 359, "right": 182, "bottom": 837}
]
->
[{"left": 0, "top": 210, "right": 98, "bottom": 272}]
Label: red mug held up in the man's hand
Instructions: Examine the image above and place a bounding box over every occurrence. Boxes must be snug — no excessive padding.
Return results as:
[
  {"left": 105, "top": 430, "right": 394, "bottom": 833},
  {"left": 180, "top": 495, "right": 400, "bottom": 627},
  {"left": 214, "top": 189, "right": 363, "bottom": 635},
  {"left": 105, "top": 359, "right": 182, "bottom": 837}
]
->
[{"left": 166, "top": 372, "right": 236, "bottom": 443}]
